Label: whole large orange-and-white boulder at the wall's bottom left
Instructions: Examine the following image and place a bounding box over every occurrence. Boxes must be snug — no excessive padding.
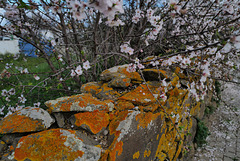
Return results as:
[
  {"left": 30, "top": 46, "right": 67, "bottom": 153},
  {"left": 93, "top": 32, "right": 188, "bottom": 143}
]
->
[{"left": 11, "top": 129, "right": 101, "bottom": 161}]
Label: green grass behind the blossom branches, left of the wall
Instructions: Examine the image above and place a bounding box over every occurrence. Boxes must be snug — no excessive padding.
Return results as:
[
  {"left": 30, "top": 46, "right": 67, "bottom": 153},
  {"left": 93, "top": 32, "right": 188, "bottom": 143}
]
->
[{"left": 0, "top": 54, "right": 79, "bottom": 116}]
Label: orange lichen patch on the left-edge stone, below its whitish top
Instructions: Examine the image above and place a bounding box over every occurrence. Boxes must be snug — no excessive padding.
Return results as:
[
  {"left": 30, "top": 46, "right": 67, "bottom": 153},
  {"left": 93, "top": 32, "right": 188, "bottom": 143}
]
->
[{"left": 0, "top": 113, "right": 45, "bottom": 134}]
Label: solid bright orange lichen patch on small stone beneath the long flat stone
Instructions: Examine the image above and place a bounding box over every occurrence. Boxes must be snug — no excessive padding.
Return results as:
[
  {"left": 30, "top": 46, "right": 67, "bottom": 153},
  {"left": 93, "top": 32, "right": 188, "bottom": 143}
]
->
[{"left": 74, "top": 110, "right": 109, "bottom": 134}]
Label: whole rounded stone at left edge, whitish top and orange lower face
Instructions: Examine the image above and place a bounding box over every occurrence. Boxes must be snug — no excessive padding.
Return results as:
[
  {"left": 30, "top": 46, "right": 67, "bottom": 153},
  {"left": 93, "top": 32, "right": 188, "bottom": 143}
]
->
[{"left": 0, "top": 107, "right": 55, "bottom": 134}]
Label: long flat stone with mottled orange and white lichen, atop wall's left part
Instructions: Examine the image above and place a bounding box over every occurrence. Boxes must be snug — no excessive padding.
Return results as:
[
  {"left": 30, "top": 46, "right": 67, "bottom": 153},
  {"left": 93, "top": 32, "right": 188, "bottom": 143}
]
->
[{"left": 45, "top": 93, "right": 113, "bottom": 112}]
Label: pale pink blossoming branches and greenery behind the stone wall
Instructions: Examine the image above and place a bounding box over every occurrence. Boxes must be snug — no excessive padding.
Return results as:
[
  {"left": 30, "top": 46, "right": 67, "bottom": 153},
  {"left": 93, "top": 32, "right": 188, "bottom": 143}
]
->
[{"left": 0, "top": 0, "right": 240, "bottom": 118}]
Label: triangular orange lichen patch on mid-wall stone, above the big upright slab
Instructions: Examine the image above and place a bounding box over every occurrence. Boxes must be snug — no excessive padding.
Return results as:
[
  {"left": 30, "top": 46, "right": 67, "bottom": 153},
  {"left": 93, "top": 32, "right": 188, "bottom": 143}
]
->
[{"left": 118, "top": 84, "right": 156, "bottom": 105}]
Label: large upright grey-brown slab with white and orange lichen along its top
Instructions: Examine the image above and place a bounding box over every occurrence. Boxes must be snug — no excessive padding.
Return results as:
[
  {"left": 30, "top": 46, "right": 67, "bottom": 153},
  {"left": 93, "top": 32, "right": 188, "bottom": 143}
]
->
[{"left": 106, "top": 111, "right": 164, "bottom": 161}]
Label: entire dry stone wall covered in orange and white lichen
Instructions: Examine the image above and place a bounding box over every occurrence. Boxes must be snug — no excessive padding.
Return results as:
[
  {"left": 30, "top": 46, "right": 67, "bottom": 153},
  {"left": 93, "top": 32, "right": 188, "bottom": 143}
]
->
[{"left": 0, "top": 65, "right": 214, "bottom": 161}]
